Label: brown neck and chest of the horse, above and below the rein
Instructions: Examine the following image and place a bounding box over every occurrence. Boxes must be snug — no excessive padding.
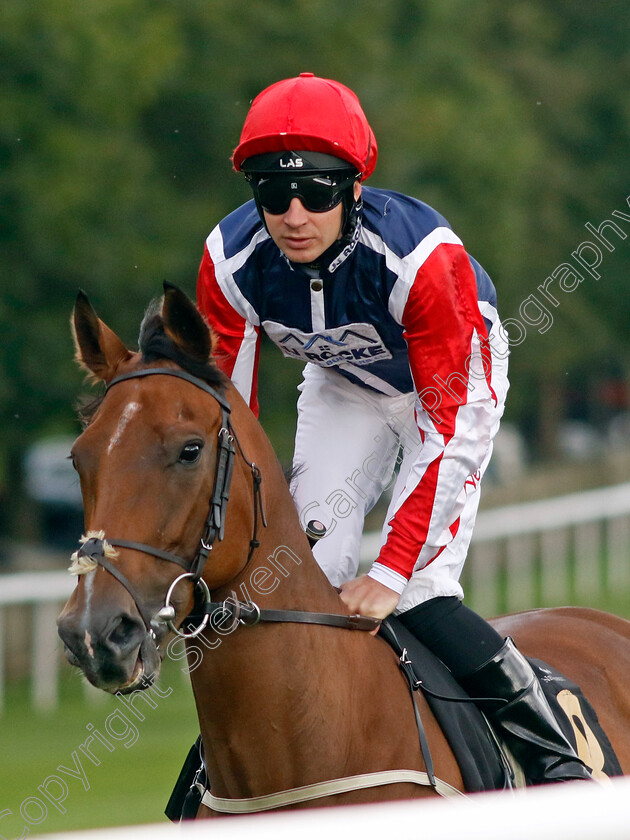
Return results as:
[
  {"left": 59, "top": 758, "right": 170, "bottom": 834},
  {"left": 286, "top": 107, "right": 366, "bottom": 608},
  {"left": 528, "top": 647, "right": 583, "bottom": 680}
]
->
[{"left": 191, "top": 394, "right": 442, "bottom": 798}]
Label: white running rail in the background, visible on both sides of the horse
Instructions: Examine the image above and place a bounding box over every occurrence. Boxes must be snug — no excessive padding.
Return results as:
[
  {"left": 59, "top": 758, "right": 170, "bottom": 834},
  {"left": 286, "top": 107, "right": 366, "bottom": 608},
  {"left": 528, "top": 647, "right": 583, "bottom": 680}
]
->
[{"left": 0, "top": 483, "right": 630, "bottom": 712}]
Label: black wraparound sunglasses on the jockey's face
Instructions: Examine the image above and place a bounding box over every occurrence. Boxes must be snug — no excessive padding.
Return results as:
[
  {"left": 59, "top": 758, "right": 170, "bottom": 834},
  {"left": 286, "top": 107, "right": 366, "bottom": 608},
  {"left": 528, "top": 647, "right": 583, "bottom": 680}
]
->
[{"left": 248, "top": 174, "right": 357, "bottom": 216}]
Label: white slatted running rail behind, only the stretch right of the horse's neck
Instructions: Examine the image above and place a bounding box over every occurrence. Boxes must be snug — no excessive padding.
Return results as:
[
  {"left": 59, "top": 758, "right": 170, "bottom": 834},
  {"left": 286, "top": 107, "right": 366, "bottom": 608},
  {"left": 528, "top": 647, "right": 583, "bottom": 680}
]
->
[{"left": 361, "top": 482, "right": 630, "bottom": 612}]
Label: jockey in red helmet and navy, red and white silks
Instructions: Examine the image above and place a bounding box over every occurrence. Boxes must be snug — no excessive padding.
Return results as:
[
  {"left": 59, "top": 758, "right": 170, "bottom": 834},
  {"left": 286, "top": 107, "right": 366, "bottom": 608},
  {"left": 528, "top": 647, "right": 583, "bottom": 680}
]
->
[{"left": 198, "top": 73, "right": 590, "bottom": 783}]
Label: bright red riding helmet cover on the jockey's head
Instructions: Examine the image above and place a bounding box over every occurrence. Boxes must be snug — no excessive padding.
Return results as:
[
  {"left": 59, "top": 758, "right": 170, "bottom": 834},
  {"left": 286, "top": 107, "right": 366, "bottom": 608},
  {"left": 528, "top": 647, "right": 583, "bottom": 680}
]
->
[{"left": 232, "top": 73, "right": 378, "bottom": 181}]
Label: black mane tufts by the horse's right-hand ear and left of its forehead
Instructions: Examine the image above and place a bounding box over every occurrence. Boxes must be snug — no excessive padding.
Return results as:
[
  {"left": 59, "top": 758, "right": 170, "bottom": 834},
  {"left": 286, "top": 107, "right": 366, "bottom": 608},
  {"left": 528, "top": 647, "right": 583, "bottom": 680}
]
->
[{"left": 76, "top": 298, "right": 228, "bottom": 428}]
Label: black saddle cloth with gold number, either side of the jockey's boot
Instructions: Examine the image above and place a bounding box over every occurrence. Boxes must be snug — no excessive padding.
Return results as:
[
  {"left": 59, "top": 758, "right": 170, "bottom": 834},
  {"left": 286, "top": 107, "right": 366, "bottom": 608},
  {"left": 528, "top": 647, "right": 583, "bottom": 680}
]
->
[{"left": 380, "top": 616, "right": 622, "bottom": 793}]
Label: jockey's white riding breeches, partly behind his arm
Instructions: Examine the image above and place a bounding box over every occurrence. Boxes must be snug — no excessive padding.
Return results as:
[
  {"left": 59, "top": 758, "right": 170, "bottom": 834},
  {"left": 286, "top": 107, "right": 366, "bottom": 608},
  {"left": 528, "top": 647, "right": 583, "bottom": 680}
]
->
[{"left": 291, "top": 365, "right": 492, "bottom": 612}]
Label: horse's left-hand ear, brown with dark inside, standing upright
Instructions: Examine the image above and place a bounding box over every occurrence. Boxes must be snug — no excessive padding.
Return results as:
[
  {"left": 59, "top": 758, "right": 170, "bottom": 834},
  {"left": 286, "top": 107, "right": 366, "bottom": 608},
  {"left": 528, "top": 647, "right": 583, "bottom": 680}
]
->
[{"left": 70, "top": 291, "right": 132, "bottom": 382}]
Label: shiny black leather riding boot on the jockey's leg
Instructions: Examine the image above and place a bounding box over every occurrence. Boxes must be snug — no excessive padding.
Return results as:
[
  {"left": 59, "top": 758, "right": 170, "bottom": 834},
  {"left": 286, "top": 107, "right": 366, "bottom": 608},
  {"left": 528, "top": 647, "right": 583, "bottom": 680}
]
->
[{"left": 459, "top": 636, "right": 592, "bottom": 784}]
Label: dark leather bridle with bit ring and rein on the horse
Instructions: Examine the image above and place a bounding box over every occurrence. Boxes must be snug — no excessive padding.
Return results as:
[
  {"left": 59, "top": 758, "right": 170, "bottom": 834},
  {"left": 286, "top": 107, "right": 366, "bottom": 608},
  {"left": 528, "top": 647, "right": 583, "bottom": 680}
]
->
[{"left": 77, "top": 367, "right": 380, "bottom": 641}]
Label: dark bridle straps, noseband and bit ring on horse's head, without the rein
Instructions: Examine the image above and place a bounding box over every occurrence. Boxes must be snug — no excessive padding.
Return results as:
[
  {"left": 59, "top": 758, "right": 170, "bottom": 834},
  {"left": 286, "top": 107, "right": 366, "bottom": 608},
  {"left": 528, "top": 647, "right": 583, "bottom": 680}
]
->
[{"left": 77, "top": 368, "right": 267, "bottom": 638}]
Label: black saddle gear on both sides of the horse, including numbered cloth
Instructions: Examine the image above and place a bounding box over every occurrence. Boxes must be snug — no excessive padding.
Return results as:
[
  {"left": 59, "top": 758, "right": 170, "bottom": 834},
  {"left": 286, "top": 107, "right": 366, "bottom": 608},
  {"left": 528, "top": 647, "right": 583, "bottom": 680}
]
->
[{"left": 165, "top": 616, "right": 623, "bottom": 822}]
